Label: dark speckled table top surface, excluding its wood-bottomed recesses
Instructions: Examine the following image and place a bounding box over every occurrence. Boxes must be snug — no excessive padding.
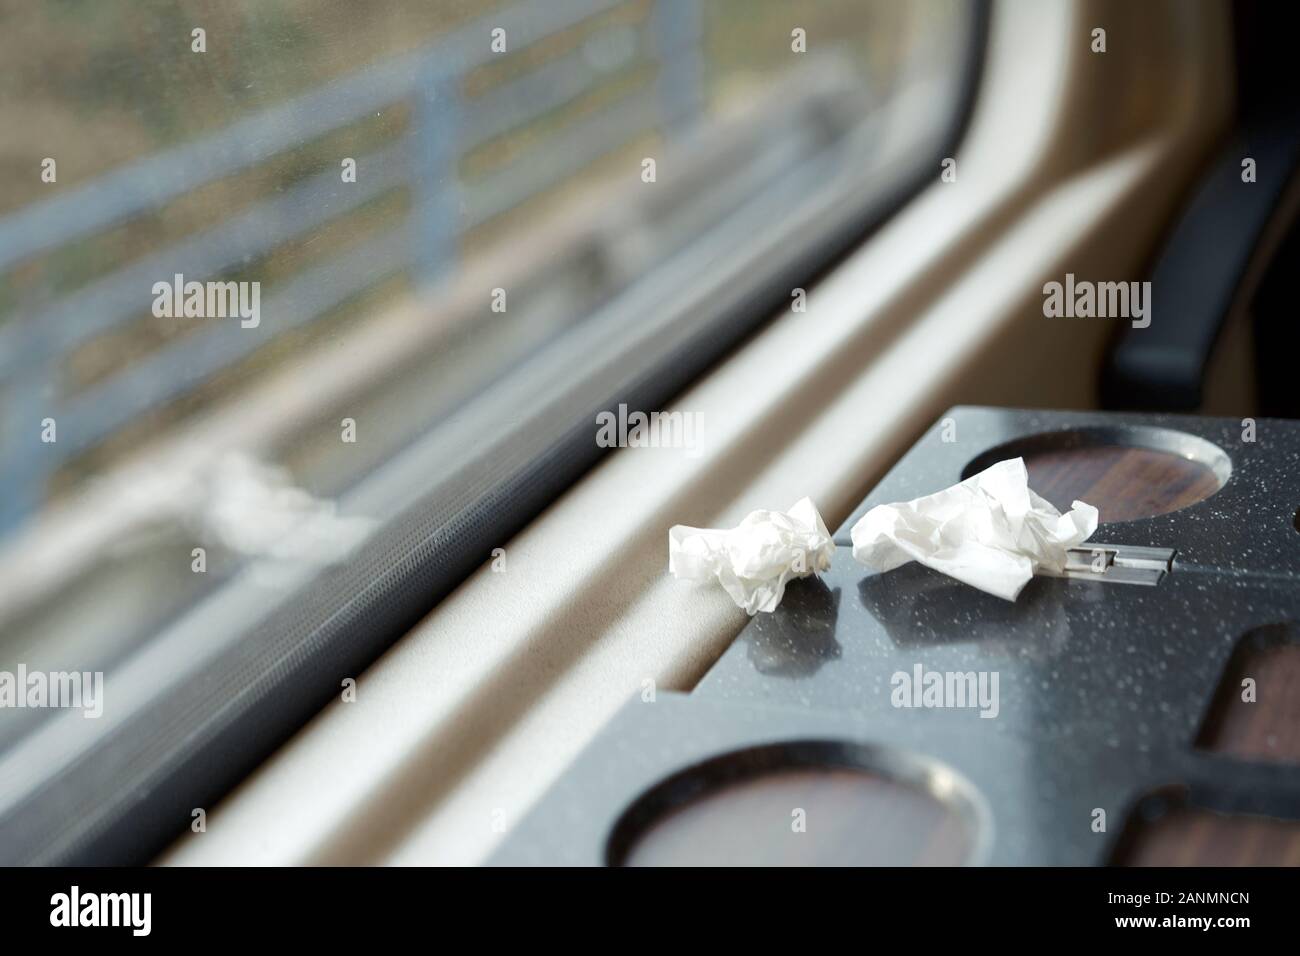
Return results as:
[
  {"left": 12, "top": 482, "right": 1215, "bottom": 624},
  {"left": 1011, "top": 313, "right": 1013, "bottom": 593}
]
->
[{"left": 495, "top": 408, "right": 1300, "bottom": 864}]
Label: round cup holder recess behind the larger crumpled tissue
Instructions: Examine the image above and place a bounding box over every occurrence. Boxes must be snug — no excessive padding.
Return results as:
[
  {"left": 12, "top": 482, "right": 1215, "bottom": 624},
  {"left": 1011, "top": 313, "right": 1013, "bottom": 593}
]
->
[{"left": 962, "top": 425, "right": 1232, "bottom": 524}]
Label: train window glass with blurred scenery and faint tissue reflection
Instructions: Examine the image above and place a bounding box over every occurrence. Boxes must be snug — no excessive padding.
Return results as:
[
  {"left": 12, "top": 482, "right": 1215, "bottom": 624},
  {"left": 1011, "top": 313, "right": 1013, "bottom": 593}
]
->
[{"left": 0, "top": 0, "right": 970, "bottom": 750}]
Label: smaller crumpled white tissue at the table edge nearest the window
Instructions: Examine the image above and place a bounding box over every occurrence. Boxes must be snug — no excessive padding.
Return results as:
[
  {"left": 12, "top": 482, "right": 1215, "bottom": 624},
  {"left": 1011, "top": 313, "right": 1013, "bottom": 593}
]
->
[{"left": 668, "top": 498, "right": 835, "bottom": 615}]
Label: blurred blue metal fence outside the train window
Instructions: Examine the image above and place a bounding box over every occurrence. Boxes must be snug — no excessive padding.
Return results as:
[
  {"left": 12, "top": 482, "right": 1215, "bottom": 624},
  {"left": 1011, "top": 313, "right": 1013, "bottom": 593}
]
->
[{"left": 0, "top": 0, "right": 703, "bottom": 532}]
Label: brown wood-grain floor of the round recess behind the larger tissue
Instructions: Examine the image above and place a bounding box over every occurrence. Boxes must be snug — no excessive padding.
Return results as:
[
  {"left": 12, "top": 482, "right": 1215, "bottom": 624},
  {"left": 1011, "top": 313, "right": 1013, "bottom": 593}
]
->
[{"left": 1024, "top": 445, "right": 1221, "bottom": 523}]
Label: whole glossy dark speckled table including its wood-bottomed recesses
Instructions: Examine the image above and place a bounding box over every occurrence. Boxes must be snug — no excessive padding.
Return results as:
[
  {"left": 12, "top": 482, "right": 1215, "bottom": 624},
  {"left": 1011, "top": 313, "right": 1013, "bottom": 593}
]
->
[{"left": 497, "top": 408, "right": 1300, "bottom": 865}]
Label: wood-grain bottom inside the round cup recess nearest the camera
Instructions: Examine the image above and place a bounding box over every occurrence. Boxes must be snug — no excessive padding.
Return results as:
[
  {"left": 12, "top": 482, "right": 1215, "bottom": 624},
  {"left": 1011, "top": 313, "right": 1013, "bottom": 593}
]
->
[{"left": 624, "top": 767, "right": 970, "bottom": 866}]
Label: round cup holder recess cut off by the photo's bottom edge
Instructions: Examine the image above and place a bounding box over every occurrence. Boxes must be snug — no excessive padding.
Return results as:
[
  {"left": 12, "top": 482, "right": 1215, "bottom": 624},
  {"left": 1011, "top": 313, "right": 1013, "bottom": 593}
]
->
[{"left": 607, "top": 741, "right": 987, "bottom": 866}]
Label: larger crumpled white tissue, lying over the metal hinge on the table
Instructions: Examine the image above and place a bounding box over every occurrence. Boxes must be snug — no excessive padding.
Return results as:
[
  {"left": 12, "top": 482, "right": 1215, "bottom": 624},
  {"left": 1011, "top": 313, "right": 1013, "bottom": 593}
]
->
[{"left": 850, "top": 458, "right": 1097, "bottom": 601}]
